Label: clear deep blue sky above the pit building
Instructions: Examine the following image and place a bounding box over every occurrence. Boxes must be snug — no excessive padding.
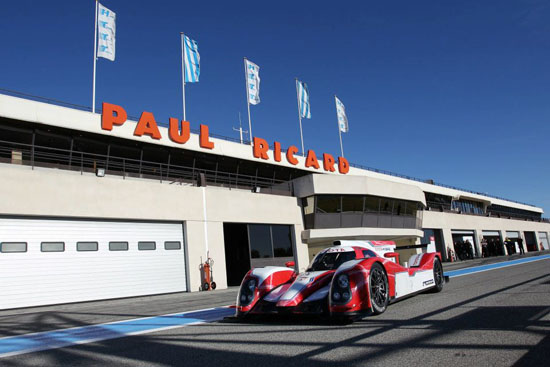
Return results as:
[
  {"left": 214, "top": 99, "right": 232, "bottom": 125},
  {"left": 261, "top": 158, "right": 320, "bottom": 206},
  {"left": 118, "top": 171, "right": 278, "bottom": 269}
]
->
[{"left": 0, "top": 0, "right": 550, "bottom": 217}]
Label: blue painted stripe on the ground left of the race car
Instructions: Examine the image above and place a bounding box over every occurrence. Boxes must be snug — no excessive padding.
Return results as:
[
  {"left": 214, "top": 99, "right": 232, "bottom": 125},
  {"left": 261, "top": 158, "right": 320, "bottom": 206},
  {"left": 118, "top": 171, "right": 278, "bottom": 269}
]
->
[{"left": 0, "top": 307, "right": 235, "bottom": 358}]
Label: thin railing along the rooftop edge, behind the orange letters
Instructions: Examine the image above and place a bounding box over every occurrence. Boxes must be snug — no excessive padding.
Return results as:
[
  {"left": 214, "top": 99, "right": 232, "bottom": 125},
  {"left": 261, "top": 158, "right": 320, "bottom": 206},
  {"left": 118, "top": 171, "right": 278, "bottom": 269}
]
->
[{"left": 0, "top": 88, "right": 534, "bottom": 206}]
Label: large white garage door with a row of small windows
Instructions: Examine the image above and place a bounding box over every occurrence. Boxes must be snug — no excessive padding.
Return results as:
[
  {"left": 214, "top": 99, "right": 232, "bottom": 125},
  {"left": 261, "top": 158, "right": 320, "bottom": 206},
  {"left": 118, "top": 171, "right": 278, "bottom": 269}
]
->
[{"left": 0, "top": 219, "right": 187, "bottom": 309}]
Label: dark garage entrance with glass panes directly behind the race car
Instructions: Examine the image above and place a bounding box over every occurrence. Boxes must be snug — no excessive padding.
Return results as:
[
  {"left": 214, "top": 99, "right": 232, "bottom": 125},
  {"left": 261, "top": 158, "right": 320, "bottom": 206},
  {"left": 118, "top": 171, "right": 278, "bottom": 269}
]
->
[{"left": 223, "top": 223, "right": 296, "bottom": 286}]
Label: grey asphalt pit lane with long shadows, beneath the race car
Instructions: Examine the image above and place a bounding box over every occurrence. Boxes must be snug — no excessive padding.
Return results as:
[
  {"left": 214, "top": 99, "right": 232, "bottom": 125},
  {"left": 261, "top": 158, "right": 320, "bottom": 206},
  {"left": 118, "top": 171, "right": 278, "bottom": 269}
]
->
[{"left": 0, "top": 257, "right": 550, "bottom": 366}]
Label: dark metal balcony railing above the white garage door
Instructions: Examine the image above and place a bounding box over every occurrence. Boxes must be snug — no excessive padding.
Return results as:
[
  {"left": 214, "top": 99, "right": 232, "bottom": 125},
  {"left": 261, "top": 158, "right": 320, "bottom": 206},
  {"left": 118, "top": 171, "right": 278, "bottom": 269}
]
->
[{"left": 0, "top": 140, "right": 291, "bottom": 196}]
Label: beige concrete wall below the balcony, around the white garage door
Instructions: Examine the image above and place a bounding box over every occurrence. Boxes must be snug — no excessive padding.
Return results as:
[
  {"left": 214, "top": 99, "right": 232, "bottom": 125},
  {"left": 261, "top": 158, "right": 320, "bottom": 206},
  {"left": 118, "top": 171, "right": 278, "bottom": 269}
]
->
[{"left": 0, "top": 164, "right": 308, "bottom": 291}]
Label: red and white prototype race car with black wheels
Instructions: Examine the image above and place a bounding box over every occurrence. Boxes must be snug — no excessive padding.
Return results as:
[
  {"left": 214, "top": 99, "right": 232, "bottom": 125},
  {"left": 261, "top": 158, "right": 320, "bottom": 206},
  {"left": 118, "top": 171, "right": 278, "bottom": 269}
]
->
[{"left": 236, "top": 241, "right": 448, "bottom": 320}]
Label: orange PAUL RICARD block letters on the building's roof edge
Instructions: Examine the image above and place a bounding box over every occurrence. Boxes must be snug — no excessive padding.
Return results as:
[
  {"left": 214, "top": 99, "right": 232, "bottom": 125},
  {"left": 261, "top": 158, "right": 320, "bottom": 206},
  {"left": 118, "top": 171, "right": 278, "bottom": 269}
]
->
[{"left": 101, "top": 102, "right": 349, "bottom": 174}]
